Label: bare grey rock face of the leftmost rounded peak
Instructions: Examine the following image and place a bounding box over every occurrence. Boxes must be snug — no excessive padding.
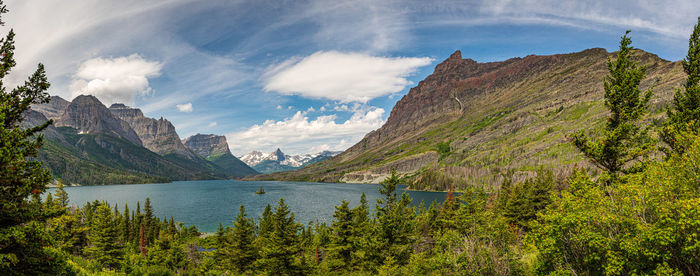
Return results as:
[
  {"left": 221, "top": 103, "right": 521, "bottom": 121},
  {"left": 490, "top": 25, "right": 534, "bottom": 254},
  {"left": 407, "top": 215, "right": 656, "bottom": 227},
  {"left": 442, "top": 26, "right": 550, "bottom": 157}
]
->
[{"left": 55, "top": 95, "right": 143, "bottom": 146}]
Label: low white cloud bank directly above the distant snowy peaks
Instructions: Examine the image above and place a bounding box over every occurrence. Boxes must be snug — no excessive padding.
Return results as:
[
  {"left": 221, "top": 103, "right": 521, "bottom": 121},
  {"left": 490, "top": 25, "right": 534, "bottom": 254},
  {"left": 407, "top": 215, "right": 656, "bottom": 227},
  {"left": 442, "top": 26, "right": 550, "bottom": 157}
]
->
[{"left": 226, "top": 107, "right": 384, "bottom": 155}]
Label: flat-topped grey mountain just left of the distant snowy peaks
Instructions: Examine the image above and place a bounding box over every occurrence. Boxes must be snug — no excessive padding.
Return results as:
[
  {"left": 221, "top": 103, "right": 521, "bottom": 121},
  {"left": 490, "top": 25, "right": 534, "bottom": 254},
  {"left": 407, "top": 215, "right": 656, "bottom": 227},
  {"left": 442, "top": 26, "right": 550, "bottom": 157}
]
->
[{"left": 182, "top": 133, "right": 258, "bottom": 177}]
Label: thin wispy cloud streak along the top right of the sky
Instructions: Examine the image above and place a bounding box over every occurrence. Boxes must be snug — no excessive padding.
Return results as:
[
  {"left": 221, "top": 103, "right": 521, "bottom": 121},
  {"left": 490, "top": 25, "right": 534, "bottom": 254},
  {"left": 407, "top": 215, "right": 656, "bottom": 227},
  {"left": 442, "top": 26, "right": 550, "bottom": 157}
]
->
[{"left": 416, "top": 0, "right": 700, "bottom": 39}]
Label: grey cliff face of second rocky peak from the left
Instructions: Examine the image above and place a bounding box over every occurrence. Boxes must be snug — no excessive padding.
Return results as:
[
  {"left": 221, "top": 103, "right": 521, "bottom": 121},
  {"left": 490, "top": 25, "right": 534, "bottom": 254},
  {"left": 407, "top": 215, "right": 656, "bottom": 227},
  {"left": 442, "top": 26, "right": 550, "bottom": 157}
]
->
[{"left": 109, "top": 104, "right": 197, "bottom": 160}]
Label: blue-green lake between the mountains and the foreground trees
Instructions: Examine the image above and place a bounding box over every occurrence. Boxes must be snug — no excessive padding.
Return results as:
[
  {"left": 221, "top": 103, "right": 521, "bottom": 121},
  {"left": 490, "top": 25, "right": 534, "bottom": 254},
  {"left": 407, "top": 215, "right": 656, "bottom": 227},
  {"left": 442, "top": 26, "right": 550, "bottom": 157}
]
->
[{"left": 49, "top": 180, "right": 445, "bottom": 233}]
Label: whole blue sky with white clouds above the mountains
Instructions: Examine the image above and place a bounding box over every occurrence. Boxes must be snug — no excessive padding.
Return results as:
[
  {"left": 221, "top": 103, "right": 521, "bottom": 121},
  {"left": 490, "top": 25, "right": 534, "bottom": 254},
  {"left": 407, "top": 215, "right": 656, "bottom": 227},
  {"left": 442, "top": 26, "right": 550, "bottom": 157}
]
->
[{"left": 0, "top": 0, "right": 700, "bottom": 156}]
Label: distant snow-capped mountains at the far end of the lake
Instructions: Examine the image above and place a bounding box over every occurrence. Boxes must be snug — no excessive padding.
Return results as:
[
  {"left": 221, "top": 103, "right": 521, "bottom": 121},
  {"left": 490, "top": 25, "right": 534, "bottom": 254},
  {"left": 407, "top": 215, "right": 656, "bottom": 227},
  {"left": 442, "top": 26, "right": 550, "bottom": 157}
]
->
[{"left": 240, "top": 149, "right": 340, "bottom": 173}]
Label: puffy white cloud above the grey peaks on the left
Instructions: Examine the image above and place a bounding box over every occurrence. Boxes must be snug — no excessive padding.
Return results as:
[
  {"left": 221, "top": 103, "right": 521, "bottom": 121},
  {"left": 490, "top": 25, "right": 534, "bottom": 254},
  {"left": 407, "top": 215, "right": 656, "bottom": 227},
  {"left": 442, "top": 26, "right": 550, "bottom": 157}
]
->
[{"left": 70, "top": 54, "right": 163, "bottom": 105}]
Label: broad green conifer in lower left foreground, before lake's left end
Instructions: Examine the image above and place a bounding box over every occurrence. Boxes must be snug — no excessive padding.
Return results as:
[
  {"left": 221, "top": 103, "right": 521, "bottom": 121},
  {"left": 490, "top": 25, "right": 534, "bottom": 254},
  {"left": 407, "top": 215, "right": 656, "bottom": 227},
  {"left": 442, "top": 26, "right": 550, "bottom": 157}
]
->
[{"left": 85, "top": 204, "right": 123, "bottom": 268}]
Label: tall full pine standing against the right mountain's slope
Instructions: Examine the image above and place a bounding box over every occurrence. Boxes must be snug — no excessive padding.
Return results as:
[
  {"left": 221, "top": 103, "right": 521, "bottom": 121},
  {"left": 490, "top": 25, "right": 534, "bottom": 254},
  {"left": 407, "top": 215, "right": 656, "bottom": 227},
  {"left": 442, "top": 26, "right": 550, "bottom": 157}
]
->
[{"left": 572, "top": 31, "right": 655, "bottom": 178}]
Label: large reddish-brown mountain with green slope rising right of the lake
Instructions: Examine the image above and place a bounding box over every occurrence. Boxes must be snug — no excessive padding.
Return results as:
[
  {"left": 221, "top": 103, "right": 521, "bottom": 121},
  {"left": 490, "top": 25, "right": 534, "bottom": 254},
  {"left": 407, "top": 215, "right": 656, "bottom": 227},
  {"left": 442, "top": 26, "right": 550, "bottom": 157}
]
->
[{"left": 250, "top": 48, "right": 685, "bottom": 190}]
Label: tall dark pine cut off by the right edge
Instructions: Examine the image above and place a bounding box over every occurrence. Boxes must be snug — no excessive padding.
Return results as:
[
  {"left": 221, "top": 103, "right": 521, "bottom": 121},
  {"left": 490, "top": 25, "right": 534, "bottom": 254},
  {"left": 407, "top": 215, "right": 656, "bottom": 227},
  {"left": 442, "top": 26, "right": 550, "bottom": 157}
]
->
[{"left": 661, "top": 17, "right": 700, "bottom": 153}]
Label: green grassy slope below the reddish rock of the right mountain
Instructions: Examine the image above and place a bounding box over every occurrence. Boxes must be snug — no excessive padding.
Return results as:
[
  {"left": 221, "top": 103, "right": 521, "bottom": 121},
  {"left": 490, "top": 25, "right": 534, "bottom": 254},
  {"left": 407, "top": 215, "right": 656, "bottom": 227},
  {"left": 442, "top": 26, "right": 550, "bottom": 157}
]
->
[{"left": 254, "top": 51, "right": 684, "bottom": 190}]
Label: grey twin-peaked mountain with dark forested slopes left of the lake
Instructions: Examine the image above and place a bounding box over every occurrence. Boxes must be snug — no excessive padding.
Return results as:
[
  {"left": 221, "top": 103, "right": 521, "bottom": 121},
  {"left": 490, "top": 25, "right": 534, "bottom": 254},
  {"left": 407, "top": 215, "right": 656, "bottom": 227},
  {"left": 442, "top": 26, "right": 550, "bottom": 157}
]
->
[{"left": 25, "top": 96, "right": 240, "bottom": 185}]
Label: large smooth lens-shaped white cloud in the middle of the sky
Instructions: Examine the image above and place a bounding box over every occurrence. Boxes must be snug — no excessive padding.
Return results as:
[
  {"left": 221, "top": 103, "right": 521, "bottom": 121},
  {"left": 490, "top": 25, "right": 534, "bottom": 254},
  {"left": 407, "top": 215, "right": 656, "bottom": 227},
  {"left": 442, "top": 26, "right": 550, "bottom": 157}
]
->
[{"left": 263, "top": 51, "right": 432, "bottom": 103}]
